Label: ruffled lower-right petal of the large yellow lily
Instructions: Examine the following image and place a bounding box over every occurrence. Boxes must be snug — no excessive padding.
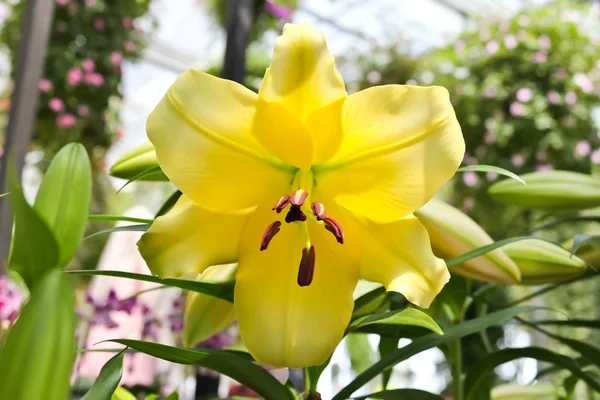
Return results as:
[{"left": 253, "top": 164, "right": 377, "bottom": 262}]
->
[{"left": 354, "top": 216, "right": 450, "bottom": 308}]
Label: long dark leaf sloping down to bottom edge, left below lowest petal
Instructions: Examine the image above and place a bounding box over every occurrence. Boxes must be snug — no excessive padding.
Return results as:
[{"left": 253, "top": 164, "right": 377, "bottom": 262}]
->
[{"left": 112, "top": 339, "right": 294, "bottom": 400}]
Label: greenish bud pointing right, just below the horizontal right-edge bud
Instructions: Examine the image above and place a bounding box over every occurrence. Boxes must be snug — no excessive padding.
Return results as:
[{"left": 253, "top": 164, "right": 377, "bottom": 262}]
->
[{"left": 503, "top": 239, "right": 586, "bottom": 285}]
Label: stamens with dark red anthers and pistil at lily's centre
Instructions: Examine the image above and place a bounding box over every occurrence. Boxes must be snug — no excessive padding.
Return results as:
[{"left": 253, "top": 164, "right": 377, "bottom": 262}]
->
[{"left": 260, "top": 170, "right": 344, "bottom": 287}]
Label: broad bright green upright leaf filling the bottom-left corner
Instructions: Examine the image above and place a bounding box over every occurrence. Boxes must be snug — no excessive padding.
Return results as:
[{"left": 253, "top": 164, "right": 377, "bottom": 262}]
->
[{"left": 0, "top": 269, "right": 76, "bottom": 400}]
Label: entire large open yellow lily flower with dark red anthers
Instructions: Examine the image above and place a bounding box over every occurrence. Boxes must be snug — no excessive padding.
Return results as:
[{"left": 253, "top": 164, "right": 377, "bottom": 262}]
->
[{"left": 139, "top": 24, "right": 464, "bottom": 368}]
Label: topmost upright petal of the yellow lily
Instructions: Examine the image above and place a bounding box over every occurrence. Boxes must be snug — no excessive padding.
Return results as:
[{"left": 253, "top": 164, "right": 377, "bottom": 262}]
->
[{"left": 258, "top": 23, "right": 346, "bottom": 122}]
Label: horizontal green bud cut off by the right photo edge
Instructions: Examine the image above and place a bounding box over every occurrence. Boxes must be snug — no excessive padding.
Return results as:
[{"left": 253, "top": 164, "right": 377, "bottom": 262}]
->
[{"left": 488, "top": 171, "right": 600, "bottom": 210}]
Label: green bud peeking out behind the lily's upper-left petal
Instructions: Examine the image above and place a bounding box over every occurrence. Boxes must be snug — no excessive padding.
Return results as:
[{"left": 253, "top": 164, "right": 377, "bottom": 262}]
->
[{"left": 110, "top": 141, "right": 168, "bottom": 181}]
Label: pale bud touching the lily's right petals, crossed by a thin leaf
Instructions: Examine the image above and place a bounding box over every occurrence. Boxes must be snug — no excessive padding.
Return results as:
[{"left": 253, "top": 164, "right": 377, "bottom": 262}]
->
[{"left": 415, "top": 199, "right": 521, "bottom": 284}]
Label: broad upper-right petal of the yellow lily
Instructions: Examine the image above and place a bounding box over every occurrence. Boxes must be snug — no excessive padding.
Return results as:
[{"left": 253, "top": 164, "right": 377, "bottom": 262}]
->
[{"left": 313, "top": 85, "right": 465, "bottom": 222}]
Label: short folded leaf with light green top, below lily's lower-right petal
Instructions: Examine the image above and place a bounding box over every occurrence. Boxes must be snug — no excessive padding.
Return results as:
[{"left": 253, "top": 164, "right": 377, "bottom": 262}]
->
[{"left": 346, "top": 308, "right": 444, "bottom": 337}]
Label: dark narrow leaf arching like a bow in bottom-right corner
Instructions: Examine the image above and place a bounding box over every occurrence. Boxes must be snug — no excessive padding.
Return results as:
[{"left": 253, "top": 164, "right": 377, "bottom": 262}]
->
[{"left": 464, "top": 347, "right": 600, "bottom": 400}]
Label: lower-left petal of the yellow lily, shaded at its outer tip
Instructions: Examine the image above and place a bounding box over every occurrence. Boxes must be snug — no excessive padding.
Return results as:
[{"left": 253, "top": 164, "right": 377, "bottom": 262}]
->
[{"left": 138, "top": 195, "right": 248, "bottom": 278}]
